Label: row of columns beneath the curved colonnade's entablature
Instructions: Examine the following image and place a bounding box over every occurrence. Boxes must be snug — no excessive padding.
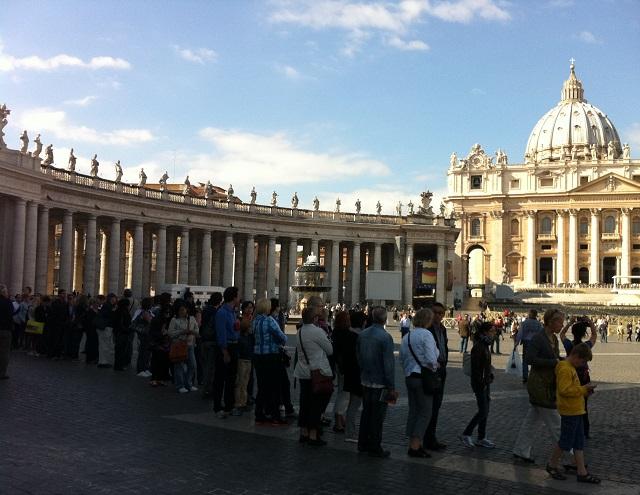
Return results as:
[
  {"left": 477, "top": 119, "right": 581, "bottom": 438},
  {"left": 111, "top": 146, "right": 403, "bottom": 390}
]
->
[{"left": 0, "top": 196, "right": 451, "bottom": 304}]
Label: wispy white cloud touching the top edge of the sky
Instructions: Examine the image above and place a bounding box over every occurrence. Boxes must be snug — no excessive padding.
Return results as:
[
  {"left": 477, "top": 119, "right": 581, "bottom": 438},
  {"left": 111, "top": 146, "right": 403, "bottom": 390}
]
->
[{"left": 269, "top": 0, "right": 511, "bottom": 57}]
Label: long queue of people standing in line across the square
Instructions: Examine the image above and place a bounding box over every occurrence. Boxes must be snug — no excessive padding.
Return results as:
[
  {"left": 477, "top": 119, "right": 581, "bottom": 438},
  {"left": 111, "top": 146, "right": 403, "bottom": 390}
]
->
[{"left": 0, "top": 286, "right": 599, "bottom": 483}]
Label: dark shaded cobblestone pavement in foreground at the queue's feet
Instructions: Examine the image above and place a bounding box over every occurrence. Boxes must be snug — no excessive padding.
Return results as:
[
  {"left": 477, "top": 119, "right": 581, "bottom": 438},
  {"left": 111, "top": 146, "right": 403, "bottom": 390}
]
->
[{"left": 0, "top": 326, "right": 640, "bottom": 495}]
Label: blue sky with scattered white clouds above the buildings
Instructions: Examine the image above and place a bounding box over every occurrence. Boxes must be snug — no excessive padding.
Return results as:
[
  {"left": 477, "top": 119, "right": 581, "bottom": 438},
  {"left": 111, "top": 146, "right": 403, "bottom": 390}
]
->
[{"left": 0, "top": 0, "right": 640, "bottom": 213}]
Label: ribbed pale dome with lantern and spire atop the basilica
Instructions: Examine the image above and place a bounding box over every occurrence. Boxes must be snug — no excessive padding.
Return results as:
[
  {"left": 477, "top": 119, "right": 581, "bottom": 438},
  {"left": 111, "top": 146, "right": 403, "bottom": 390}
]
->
[{"left": 525, "top": 62, "right": 622, "bottom": 163}]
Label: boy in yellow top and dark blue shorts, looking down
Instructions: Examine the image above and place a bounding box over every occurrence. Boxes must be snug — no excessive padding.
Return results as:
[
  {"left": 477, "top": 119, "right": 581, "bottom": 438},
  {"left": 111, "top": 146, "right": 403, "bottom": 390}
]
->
[{"left": 547, "top": 343, "right": 600, "bottom": 485}]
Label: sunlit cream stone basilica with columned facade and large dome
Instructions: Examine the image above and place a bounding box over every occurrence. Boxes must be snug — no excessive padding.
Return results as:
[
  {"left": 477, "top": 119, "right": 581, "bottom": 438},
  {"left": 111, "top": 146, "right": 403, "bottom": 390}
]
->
[{"left": 447, "top": 62, "right": 640, "bottom": 295}]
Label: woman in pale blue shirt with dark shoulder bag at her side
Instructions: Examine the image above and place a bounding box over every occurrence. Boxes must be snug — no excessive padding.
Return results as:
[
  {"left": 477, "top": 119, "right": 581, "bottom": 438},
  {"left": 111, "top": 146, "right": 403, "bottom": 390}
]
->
[{"left": 400, "top": 308, "right": 439, "bottom": 458}]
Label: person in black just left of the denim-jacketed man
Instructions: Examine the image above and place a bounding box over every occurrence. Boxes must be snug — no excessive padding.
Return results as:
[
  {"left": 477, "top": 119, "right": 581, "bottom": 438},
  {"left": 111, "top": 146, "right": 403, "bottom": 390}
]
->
[{"left": 341, "top": 311, "right": 367, "bottom": 443}]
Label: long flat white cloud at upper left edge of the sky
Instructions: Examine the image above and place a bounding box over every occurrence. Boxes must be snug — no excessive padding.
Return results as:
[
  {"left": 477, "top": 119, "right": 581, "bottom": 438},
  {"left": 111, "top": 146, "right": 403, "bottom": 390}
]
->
[{"left": 0, "top": 42, "right": 131, "bottom": 72}]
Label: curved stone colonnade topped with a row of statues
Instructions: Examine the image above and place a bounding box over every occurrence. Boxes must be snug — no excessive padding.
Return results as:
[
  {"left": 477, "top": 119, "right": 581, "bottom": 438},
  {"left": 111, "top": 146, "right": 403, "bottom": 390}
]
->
[{"left": 0, "top": 106, "right": 458, "bottom": 305}]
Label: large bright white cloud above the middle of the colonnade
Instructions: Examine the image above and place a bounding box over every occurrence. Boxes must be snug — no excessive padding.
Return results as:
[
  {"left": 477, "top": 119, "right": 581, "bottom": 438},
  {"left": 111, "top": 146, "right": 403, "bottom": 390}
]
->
[{"left": 184, "top": 127, "right": 391, "bottom": 191}]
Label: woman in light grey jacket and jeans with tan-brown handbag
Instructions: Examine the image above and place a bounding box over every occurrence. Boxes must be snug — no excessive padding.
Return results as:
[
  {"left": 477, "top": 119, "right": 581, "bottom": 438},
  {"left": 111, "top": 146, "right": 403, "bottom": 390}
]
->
[{"left": 168, "top": 299, "right": 198, "bottom": 394}]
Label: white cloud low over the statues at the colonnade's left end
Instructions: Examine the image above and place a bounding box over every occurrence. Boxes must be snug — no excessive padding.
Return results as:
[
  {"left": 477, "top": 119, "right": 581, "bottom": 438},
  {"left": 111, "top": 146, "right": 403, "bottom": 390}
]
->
[{"left": 18, "top": 108, "right": 155, "bottom": 146}]
